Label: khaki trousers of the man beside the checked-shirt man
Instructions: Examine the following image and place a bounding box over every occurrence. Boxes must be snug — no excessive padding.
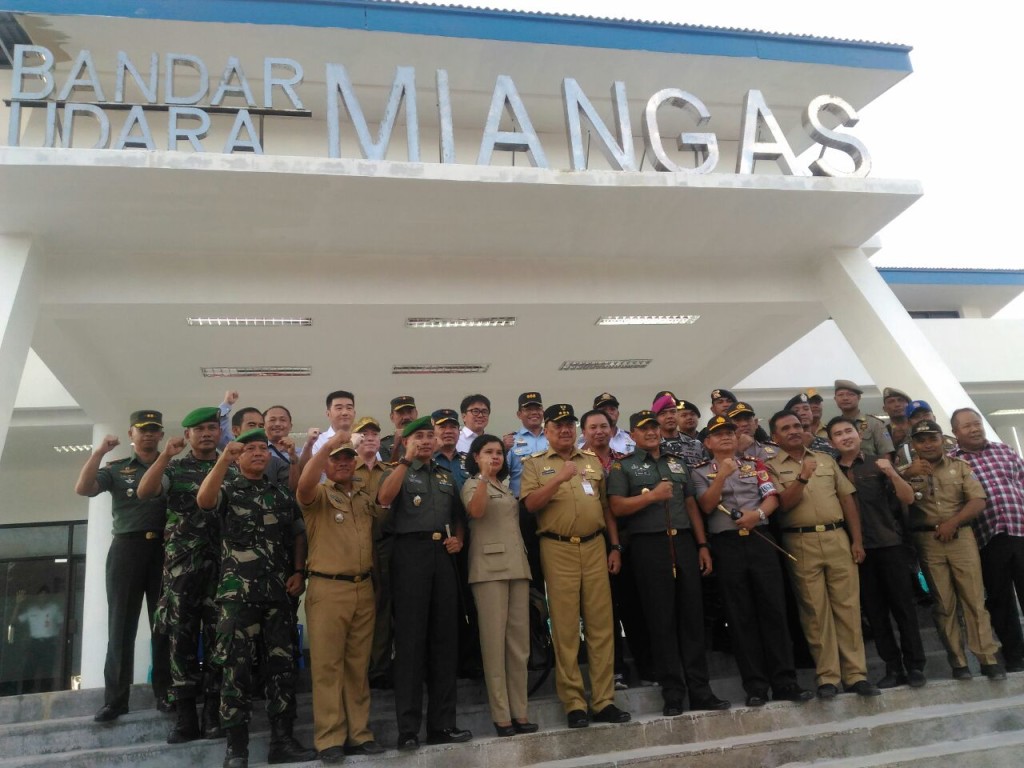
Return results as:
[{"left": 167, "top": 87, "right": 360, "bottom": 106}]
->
[{"left": 913, "top": 527, "right": 999, "bottom": 667}]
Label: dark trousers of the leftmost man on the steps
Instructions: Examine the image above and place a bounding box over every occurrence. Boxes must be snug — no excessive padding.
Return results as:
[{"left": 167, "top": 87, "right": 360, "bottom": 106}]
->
[{"left": 103, "top": 537, "right": 171, "bottom": 708}]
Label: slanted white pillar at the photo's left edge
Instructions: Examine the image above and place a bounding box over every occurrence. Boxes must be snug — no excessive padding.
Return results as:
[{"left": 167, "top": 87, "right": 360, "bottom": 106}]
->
[{"left": 0, "top": 234, "right": 41, "bottom": 457}]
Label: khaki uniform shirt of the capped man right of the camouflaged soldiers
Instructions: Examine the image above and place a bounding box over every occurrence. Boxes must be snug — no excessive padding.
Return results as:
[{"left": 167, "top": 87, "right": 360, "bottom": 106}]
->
[{"left": 299, "top": 481, "right": 377, "bottom": 575}]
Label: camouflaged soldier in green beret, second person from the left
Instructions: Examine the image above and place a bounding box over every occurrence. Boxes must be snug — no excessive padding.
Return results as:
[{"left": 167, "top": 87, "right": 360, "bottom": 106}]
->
[{"left": 136, "top": 408, "right": 228, "bottom": 744}]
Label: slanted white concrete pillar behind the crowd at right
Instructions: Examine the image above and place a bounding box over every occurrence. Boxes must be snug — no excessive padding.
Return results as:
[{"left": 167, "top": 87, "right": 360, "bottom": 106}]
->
[{"left": 819, "top": 249, "right": 995, "bottom": 434}]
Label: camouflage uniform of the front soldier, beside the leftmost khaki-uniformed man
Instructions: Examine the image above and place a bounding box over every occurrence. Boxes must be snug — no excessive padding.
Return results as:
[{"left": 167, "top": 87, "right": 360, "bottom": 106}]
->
[{"left": 209, "top": 475, "right": 297, "bottom": 728}]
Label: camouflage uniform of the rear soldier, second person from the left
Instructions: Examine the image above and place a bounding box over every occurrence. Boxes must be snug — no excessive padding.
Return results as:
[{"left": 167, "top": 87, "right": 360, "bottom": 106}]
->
[{"left": 155, "top": 454, "right": 233, "bottom": 701}]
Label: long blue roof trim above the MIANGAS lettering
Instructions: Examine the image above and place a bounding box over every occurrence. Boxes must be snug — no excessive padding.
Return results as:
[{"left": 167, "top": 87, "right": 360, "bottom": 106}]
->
[{"left": 4, "top": 0, "right": 912, "bottom": 72}]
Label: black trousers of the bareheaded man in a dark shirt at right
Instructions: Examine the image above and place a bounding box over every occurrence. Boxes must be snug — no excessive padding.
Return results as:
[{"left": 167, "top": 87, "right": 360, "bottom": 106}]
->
[{"left": 860, "top": 546, "right": 926, "bottom": 670}]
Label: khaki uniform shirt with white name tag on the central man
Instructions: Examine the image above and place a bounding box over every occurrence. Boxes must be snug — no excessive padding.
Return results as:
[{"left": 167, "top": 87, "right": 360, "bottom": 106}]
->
[{"left": 520, "top": 449, "right": 608, "bottom": 537}]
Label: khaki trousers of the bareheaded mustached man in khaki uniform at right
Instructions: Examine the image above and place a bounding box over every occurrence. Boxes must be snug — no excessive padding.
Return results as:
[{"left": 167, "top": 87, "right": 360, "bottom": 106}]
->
[{"left": 782, "top": 528, "right": 867, "bottom": 685}]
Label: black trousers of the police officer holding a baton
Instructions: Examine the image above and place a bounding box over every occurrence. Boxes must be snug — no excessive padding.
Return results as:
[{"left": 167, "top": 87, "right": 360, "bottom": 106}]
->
[{"left": 711, "top": 526, "right": 797, "bottom": 696}]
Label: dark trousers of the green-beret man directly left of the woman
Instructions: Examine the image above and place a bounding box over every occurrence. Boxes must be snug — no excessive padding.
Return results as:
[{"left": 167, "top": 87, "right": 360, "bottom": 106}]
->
[{"left": 391, "top": 536, "right": 460, "bottom": 733}]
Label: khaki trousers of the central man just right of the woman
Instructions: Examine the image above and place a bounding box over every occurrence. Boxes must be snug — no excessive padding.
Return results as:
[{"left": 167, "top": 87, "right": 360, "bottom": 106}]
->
[{"left": 541, "top": 536, "right": 615, "bottom": 713}]
